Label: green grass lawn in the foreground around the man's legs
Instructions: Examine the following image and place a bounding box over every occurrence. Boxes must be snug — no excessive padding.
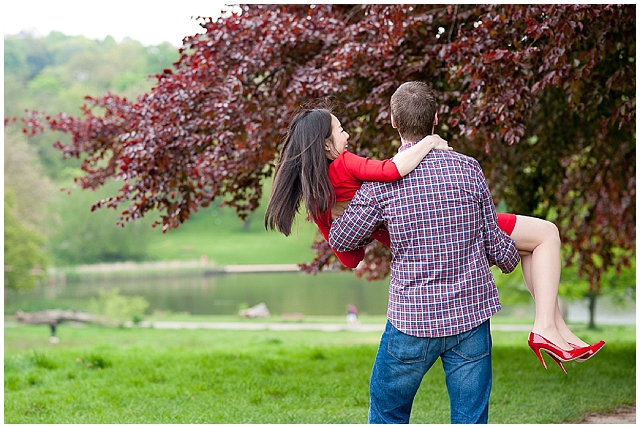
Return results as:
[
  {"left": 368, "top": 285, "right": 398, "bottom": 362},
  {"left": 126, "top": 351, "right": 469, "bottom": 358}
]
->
[{"left": 4, "top": 325, "right": 636, "bottom": 424}]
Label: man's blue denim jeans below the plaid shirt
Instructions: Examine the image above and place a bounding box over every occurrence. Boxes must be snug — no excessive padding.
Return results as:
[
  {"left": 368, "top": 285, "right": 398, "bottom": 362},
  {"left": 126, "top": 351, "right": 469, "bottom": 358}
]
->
[{"left": 369, "top": 320, "right": 492, "bottom": 424}]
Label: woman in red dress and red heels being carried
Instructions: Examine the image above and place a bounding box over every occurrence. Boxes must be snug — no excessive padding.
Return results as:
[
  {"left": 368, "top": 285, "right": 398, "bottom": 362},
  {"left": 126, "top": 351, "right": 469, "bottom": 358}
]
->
[{"left": 265, "top": 109, "right": 604, "bottom": 373}]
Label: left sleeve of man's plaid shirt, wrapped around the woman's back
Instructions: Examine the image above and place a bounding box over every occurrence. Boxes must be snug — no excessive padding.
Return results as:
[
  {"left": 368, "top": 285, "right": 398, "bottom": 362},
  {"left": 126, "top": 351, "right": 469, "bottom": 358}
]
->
[{"left": 329, "top": 183, "right": 382, "bottom": 251}]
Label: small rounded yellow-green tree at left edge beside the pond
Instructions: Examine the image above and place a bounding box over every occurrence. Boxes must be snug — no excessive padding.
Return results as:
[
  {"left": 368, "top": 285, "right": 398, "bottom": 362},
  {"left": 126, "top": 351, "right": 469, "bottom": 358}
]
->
[{"left": 4, "top": 190, "right": 48, "bottom": 290}]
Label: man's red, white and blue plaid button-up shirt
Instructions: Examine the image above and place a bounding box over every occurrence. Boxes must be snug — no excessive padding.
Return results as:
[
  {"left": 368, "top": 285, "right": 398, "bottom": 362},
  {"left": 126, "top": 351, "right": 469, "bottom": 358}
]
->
[{"left": 329, "top": 147, "right": 520, "bottom": 337}]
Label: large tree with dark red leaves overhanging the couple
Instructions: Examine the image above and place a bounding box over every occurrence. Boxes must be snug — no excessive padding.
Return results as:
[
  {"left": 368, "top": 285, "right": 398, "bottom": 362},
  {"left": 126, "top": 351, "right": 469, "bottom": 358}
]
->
[{"left": 20, "top": 5, "right": 636, "bottom": 290}]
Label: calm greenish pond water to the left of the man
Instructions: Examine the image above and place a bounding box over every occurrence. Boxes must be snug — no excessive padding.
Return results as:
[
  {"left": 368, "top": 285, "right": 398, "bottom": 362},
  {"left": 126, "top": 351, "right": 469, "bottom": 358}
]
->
[{"left": 6, "top": 272, "right": 388, "bottom": 315}]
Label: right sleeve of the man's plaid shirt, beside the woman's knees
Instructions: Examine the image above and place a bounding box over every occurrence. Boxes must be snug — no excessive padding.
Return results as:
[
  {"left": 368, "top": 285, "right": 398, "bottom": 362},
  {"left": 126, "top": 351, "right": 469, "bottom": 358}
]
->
[{"left": 474, "top": 159, "right": 520, "bottom": 273}]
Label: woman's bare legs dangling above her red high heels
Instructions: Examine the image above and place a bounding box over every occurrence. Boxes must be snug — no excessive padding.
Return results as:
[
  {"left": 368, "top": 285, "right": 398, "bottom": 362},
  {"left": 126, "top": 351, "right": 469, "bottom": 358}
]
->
[{"left": 511, "top": 216, "right": 584, "bottom": 350}]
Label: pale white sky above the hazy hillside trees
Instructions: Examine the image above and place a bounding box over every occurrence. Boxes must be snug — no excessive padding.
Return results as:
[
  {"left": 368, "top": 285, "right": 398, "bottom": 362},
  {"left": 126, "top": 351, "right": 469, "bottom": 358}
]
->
[{"left": 0, "top": 0, "right": 232, "bottom": 47}]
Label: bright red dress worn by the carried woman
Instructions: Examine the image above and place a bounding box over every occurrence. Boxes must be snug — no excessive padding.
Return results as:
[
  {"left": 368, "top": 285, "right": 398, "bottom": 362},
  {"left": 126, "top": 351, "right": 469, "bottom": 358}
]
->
[{"left": 315, "top": 151, "right": 516, "bottom": 269}]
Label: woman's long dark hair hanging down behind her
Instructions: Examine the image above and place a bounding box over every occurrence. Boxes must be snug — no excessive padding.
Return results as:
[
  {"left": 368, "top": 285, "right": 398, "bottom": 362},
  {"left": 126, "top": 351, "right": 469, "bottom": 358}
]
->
[{"left": 264, "top": 109, "right": 335, "bottom": 236}]
